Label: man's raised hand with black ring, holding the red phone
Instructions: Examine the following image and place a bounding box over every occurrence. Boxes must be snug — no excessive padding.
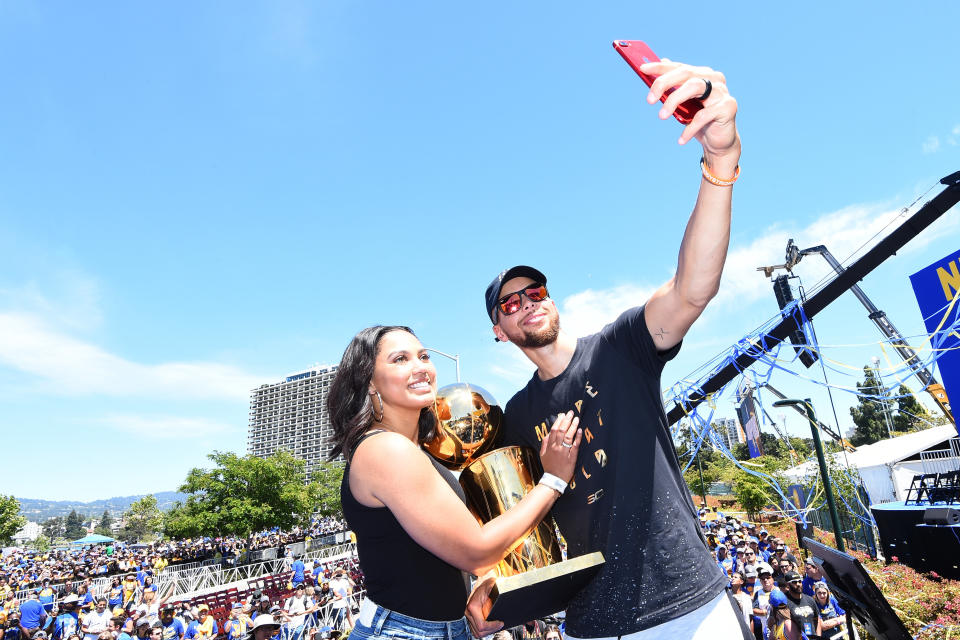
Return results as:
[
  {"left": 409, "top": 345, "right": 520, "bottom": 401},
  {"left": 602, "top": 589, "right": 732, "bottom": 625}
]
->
[{"left": 640, "top": 58, "right": 740, "bottom": 168}]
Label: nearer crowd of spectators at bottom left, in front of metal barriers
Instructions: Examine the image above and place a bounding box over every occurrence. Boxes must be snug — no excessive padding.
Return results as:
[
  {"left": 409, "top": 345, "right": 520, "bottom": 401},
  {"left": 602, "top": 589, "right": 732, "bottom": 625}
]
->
[{"left": 0, "top": 557, "right": 363, "bottom": 640}]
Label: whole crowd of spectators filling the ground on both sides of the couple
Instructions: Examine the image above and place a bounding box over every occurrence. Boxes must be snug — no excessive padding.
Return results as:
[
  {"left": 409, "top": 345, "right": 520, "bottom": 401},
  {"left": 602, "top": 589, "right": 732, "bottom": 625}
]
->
[{"left": 0, "top": 512, "right": 845, "bottom": 640}]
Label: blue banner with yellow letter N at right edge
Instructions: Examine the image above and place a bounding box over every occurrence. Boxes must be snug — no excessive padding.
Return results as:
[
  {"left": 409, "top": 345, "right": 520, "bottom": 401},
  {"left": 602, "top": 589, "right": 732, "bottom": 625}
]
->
[{"left": 910, "top": 251, "right": 960, "bottom": 433}]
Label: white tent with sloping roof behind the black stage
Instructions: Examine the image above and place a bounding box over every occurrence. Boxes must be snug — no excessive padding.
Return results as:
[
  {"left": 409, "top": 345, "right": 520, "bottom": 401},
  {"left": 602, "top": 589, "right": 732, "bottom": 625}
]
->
[{"left": 785, "top": 425, "right": 960, "bottom": 504}]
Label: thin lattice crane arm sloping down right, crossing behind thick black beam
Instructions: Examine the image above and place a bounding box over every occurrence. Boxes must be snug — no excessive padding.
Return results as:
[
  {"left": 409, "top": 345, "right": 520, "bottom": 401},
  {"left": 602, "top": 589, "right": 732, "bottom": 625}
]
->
[{"left": 757, "top": 238, "right": 954, "bottom": 424}]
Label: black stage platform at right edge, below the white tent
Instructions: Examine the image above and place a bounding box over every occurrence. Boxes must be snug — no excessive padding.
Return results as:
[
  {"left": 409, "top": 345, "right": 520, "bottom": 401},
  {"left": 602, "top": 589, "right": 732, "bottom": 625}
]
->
[{"left": 870, "top": 501, "right": 960, "bottom": 580}]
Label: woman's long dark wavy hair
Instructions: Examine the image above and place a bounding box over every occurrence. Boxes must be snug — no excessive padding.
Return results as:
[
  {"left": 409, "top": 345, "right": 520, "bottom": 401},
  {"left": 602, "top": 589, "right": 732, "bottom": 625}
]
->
[{"left": 327, "top": 325, "right": 437, "bottom": 462}]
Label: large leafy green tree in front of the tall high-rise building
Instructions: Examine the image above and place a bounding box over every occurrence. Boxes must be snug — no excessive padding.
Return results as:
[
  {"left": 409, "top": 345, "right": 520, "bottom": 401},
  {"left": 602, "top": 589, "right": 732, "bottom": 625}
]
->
[{"left": 164, "top": 449, "right": 326, "bottom": 538}]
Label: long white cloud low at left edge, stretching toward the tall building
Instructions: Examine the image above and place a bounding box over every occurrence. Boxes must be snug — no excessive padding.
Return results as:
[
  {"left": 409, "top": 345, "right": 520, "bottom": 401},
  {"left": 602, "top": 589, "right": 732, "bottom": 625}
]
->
[{"left": 0, "top": 312, "right": 262, "bottom": 399}]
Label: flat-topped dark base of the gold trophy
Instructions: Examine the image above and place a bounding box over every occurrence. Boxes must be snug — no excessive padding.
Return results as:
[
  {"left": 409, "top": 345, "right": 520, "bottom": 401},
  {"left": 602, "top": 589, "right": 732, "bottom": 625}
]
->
[{"left": 486, "top": 551, "right": 604, "bottom": 628}]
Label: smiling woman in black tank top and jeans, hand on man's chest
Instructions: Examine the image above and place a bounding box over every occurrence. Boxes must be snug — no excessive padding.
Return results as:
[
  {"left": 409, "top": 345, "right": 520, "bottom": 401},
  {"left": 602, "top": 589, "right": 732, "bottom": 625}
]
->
[{"left": 327, "top": 326, "right": 582, "bottom": 640}]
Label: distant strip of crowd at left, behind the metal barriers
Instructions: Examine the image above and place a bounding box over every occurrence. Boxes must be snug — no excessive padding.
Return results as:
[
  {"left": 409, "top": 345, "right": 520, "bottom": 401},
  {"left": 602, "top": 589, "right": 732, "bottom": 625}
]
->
[{"left": 0, "top": 517, "right": 347, "bottom": 596}]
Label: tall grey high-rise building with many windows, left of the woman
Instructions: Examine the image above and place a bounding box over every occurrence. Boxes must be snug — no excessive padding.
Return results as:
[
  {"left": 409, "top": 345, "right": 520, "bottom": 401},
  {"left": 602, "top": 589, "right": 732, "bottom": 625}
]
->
[{"left": 247, "top": 365, "right": 337, "bottom": 479}]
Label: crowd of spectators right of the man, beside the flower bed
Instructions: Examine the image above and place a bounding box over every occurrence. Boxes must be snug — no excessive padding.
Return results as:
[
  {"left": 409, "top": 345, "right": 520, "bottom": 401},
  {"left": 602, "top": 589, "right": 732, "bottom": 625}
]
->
[{"left": 700, "top": 511, "right": 846, "bottom": 640}]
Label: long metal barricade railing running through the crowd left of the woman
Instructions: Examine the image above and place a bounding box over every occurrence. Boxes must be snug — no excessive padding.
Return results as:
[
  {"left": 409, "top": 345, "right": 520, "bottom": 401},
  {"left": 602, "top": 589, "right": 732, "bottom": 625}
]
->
[{"left": 155, "top": 543, "right": 357, "bottom": 599}]
